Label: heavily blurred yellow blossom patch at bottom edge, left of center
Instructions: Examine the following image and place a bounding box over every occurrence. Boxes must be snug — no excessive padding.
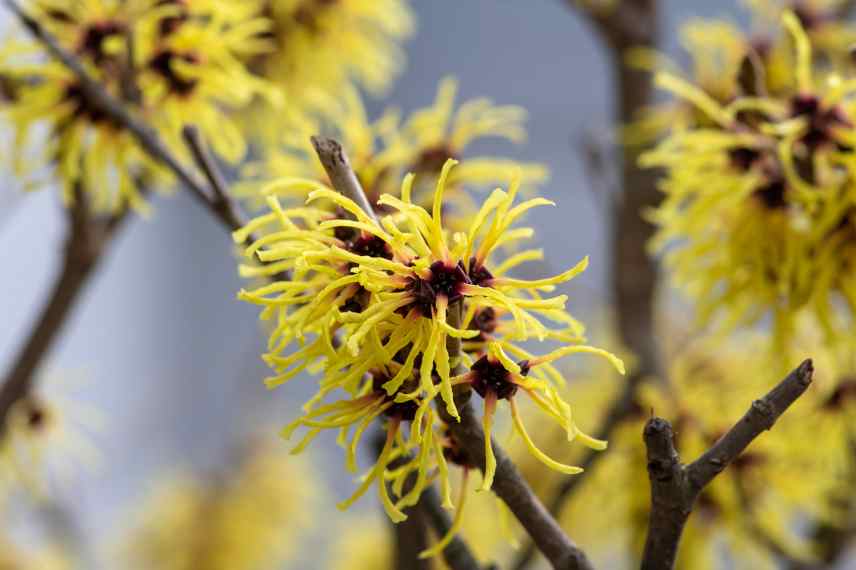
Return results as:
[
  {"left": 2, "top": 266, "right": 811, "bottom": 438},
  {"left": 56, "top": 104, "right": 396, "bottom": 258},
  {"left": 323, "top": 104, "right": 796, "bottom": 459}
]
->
[{"left": 117, "top": 441, "right": 318, "bottom": 570}]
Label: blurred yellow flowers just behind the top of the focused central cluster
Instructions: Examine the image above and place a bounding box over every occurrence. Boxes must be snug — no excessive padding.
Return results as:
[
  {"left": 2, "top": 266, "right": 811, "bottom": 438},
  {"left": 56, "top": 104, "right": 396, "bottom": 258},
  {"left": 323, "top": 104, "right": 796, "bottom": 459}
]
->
[{"left": 238, "top": 78, "right": 547, "bottom": 229}]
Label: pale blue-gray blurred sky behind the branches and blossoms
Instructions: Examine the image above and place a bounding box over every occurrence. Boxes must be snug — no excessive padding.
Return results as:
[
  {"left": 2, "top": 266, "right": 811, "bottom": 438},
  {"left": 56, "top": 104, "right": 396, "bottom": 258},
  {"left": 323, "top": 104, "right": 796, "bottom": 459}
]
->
[{"left": 0, "top": 0, "right": 756, "bottom": 564}]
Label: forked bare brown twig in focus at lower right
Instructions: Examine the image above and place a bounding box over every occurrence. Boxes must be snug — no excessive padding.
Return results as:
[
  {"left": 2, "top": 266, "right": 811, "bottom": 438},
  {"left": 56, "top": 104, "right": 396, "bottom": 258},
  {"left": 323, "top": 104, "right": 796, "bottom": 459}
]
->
[{"left": 641, "top": 360, "right": 814, "bottom": 570}]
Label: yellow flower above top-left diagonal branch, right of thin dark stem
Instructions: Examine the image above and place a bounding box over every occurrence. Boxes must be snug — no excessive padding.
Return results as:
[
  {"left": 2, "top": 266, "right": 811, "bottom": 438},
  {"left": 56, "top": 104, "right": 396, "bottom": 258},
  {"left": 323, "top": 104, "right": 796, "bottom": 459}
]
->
[{"left": 134, "top": 0, "right": 281, "bottom": 163}]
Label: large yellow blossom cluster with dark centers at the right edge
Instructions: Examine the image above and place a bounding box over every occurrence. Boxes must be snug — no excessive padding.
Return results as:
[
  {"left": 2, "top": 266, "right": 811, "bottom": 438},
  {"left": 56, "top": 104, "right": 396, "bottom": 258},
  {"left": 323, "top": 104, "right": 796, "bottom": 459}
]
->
[{"left": 643, "top": 5, "right": 856, "bottom": 356}]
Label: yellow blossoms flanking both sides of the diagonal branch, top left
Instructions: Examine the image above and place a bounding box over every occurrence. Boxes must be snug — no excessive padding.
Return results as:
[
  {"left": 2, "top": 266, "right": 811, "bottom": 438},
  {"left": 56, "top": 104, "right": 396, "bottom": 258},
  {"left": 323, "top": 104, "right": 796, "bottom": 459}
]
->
[{"left": 0, "top": 0, "right": 268, "bottom": 212}]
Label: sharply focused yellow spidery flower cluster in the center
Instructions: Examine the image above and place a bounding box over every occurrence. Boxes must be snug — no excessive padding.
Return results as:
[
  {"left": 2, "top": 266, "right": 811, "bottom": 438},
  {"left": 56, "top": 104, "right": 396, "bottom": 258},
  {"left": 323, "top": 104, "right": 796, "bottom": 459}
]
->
[{"left": 234, "top": 160, "right": 623, "bottom": 536}]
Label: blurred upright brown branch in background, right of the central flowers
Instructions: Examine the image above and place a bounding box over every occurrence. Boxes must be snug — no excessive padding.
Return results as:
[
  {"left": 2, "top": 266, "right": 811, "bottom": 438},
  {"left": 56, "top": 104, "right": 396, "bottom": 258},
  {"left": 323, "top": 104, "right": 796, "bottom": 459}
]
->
[{"left": 511, "top": 0, "right": 660, "bottom": 570}]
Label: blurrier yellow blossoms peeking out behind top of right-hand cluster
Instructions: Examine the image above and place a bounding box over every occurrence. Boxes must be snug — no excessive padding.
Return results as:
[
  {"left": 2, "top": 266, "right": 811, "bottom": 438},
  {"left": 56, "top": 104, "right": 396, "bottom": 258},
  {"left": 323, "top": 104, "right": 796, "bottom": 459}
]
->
[{"left": 624, "top": 0, "right": 856, "bottom": 144}]
